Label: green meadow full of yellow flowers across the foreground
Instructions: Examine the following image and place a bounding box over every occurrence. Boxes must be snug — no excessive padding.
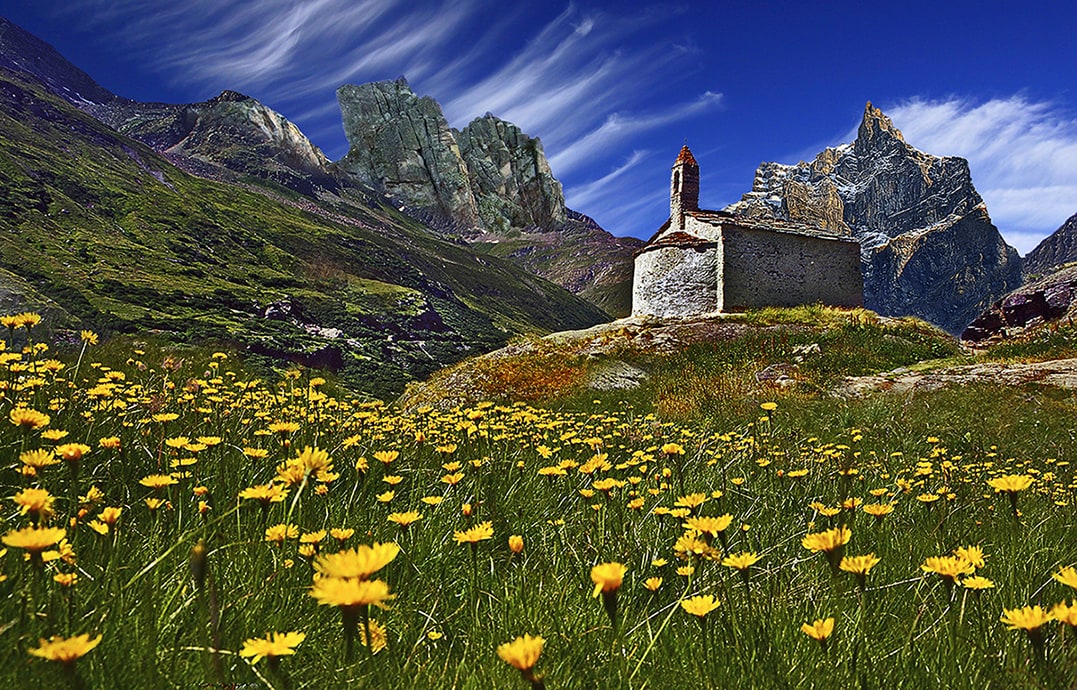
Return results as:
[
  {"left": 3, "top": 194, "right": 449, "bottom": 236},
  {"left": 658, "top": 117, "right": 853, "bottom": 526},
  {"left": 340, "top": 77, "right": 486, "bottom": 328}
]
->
[{"left": 0, "top": 314, "right": 1077, "bottom": 689}]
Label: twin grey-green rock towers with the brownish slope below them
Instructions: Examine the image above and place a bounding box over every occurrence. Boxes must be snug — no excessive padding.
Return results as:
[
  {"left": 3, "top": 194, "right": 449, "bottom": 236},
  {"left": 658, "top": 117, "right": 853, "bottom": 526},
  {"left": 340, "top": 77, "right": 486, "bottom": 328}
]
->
[{"left": 337, "top": 79, "right": 642, "bottom": 315}]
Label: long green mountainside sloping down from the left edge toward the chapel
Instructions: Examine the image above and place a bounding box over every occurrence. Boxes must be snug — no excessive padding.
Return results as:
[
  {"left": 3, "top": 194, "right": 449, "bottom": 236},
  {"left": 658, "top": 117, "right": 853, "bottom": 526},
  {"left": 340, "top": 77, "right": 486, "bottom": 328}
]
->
[{"left": 0, "top": 72, "right": 606, "bottom": 395}]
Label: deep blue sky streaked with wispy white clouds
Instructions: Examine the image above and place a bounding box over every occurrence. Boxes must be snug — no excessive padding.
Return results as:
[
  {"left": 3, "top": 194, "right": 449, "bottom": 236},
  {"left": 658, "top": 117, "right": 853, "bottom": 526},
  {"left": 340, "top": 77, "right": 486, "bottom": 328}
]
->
[{"left": 0, "top": 0, "right": 1077, "bottom": 254}]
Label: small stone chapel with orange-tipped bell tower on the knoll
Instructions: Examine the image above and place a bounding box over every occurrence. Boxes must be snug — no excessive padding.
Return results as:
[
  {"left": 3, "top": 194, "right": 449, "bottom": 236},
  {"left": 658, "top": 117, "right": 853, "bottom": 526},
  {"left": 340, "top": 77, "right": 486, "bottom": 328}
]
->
[{"left": 632, "top": 145, "right": 864, "bottom": 318}]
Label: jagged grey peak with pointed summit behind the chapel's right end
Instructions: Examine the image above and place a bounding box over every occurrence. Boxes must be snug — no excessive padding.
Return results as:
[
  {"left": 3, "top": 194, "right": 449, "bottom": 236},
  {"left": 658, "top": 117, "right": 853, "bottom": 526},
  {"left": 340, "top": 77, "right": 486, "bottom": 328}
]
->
[{"left": 728, "top": 103, "right": 1021, "bottom": 333}]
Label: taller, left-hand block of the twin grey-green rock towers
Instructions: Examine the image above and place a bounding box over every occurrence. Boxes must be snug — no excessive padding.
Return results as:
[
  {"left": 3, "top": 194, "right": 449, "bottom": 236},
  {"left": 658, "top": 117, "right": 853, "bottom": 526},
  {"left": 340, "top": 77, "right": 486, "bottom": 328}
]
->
[{"left": 337, "top": 78, "right": 478, "bottom": 228}]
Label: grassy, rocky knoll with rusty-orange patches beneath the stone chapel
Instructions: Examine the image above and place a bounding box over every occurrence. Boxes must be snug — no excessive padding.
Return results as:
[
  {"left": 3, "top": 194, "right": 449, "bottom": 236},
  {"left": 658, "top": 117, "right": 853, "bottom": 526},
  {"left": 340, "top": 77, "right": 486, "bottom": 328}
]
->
[{"left": 401, "top": 307, "right": 960, "bottom": 421}]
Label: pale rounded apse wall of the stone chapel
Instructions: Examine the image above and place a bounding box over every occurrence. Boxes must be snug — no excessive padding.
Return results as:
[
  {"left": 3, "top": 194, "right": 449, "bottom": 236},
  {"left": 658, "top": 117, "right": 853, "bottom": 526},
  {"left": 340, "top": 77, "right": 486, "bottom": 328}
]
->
[{"left": 632, "top": 244, "right": 721, "bottom": 316}]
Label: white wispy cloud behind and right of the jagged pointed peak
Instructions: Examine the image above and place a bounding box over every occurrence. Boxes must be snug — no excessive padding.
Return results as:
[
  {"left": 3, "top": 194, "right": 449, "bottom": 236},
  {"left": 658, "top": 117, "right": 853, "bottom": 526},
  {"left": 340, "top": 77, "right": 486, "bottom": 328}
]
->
[{"left": 885, "top": 95, "right": 1077, "bottom": 254}]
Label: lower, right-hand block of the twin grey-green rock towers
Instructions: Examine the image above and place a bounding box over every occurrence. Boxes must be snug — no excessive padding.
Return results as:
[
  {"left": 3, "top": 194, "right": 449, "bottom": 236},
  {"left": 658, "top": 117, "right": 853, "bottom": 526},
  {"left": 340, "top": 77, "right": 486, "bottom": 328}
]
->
[{"left": 457, "top": 113, "right": 565, "bottom": 234}]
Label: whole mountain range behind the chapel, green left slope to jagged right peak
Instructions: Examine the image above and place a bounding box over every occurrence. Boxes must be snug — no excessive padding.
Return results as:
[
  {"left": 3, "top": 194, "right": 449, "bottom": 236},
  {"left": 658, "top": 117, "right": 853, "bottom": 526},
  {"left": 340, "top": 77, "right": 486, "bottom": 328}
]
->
[{"left": 0, "top": 18, "right": 1077, "bottom": 376}]
